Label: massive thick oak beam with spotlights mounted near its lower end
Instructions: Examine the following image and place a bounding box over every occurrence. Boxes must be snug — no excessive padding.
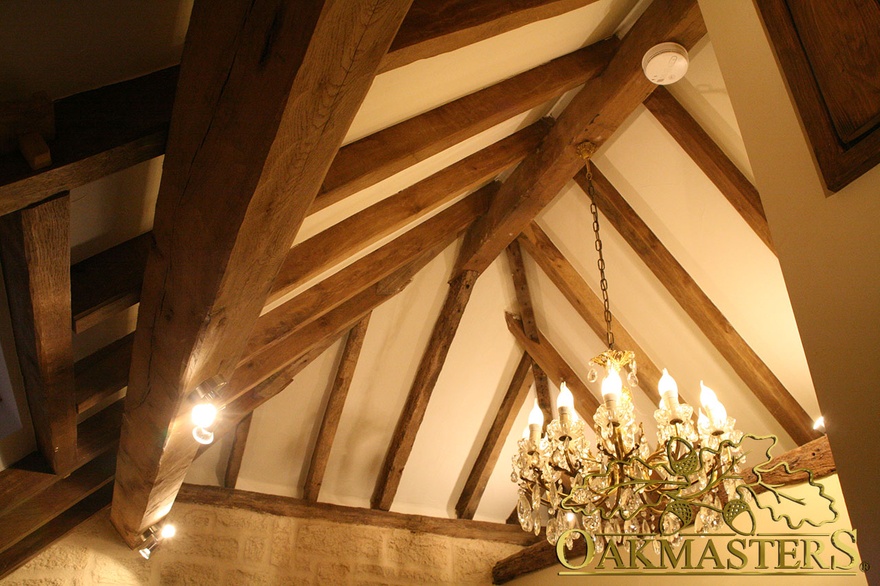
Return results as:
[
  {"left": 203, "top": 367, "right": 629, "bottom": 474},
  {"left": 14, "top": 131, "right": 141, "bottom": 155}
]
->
[{"left": 111, "top": 0, "right": 410, "bottom": 546}]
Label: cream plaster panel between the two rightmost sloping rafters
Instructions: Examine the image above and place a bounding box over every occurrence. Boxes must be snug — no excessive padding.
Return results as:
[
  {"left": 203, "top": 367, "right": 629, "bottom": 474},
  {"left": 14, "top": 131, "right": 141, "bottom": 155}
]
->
[{"left": 597, "top": 108, "right": 818, "bottom": 417}]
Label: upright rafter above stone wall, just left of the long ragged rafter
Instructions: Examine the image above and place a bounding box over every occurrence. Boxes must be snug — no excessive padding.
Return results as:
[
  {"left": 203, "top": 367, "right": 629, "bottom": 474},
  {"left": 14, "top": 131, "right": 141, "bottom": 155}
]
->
[{"left": 303, "top": 314, "right": 370, "bottom": 502}]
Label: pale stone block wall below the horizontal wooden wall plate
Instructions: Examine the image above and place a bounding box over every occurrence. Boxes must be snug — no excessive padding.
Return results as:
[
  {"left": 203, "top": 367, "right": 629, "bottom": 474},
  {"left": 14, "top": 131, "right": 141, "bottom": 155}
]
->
[{"left": 0, "top": 503, "right": 519, "bottom": 586}]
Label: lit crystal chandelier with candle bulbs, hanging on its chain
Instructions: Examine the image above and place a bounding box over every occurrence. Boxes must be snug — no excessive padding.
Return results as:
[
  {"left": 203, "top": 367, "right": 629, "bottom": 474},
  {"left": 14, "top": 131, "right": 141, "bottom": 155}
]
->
[{"left": 511, "top": 150, "right": 755, "bottom": 552}]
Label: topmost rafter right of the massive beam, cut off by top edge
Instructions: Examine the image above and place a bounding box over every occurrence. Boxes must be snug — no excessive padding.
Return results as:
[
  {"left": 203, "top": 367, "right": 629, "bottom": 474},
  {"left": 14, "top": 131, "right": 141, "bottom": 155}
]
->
[{"left": 379, "top": 0, "right": 596, "bottom": 72}]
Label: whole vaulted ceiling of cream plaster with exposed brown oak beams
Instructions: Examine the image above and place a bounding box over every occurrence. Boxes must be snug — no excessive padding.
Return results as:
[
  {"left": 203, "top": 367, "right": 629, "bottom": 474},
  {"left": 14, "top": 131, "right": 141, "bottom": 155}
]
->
[{"left": 0, "top": 0, "right": 872, "bottom": 580}]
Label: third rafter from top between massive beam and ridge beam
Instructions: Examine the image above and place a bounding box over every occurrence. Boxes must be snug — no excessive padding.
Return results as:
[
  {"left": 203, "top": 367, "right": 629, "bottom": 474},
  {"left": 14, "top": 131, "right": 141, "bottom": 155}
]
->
[{"left": 269, "top": 120, "right": 550, "bottom": 302}]
